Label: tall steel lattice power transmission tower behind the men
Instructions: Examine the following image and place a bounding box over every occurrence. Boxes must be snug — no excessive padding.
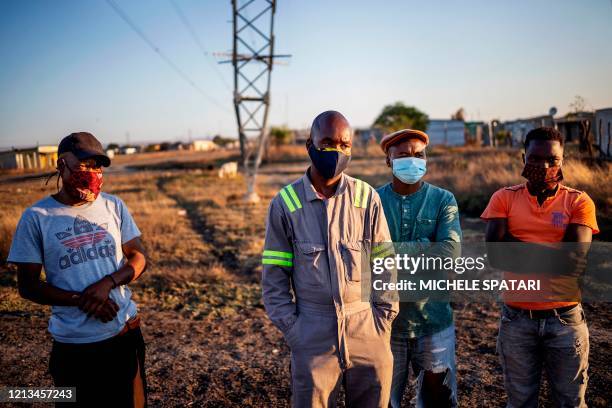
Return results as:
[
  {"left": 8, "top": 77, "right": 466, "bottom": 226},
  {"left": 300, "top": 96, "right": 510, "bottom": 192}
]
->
[{"left": 231, "top": 0, "right": 290, "bottom": 201}]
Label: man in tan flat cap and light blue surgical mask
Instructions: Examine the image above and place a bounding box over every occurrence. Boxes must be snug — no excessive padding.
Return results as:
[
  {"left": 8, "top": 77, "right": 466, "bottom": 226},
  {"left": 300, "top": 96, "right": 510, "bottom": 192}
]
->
[{"left": 377, "top": 129, "right": 461, "bottom": 407}]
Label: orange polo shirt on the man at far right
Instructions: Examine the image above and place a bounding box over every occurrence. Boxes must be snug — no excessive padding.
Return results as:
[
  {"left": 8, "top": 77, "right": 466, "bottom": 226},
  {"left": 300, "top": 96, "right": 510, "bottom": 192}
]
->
[{"left": 480, "top": 183, "right": 599, "bottom": 310}]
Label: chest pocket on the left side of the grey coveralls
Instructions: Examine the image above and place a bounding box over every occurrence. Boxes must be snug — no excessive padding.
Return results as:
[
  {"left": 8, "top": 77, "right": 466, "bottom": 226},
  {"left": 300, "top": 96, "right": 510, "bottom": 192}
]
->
[{"left": 293, "top": 242, "right": 329, "bottom": 287}]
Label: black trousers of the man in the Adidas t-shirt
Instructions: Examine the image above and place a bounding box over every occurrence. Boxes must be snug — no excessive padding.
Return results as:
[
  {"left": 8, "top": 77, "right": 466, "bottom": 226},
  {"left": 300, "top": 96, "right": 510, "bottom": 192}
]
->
[{"left": 49, "top": 328, "right": 147, "bottom": 408}]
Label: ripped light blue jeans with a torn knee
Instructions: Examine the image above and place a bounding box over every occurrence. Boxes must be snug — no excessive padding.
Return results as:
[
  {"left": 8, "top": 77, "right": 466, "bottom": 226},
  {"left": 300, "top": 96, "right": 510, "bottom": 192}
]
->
[{"left": 390, "top": 324, "right": 457, "bottom": 408}]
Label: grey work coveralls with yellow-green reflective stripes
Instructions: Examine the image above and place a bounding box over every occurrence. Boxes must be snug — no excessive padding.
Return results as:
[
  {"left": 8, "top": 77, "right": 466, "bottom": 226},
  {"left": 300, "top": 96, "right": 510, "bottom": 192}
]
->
[{"left": 262, "top": 174, "right": 398, "bottom": 407}]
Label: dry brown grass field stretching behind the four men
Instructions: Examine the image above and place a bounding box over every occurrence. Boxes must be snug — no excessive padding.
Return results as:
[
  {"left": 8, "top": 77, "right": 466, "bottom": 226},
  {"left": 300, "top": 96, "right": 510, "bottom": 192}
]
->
[{"left": 0, "top": 146, "right": 612, "bottom": 407}]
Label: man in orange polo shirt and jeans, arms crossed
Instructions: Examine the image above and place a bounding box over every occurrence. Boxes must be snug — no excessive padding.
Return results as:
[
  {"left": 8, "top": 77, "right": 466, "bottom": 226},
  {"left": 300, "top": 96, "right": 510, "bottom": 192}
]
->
[{"left": 481, "top": 128, "right": 599, "bottom": 407}]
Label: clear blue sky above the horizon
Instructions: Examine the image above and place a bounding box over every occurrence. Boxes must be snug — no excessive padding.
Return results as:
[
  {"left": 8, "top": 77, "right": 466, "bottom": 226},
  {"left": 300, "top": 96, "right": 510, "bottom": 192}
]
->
[{"left": 0, "top": 0, "right": 612, "bottom": 148}]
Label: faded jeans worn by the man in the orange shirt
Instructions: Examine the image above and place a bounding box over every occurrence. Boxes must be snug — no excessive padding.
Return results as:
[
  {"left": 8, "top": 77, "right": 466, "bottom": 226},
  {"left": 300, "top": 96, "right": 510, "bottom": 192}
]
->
[{"left": 497, "top": 305, "right": 589, "bottom": 408}]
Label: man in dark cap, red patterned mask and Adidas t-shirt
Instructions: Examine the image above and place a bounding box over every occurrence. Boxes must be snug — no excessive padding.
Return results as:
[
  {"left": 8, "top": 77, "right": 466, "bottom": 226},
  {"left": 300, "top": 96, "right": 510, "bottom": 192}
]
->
[{"left": 8, "top": 132, "right": 146, "bottom": 406}]
